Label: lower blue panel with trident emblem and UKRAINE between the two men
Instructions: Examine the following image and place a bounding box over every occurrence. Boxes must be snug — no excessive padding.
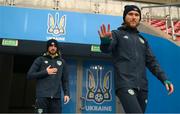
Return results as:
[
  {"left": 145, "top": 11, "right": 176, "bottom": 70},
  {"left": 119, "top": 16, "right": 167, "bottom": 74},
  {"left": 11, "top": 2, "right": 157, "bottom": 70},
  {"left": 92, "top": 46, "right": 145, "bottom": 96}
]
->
[{"left": 81, "top": 61, "right": 116, "bottom": 113}]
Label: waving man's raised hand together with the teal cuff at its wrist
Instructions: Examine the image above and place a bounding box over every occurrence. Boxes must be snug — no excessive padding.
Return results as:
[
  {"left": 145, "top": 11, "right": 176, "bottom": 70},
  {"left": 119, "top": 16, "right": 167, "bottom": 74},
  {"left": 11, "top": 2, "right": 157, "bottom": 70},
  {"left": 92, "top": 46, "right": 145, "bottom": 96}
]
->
[{"left": 98, "top": 24, "right": 112, "bottom": 44}]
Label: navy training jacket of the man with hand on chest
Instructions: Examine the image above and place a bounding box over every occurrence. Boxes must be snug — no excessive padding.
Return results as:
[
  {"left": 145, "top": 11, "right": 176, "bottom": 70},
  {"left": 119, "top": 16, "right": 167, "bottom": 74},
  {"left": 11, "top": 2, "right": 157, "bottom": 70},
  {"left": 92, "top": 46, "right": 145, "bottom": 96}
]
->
[{"left": 27, "top": 55, "right": 69, "bottom": 98}]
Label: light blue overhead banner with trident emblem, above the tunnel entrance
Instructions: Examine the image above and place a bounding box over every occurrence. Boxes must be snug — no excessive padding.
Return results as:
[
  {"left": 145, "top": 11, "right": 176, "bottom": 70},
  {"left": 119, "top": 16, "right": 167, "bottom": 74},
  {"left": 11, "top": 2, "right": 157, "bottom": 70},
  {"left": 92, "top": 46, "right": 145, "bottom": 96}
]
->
[{"left": 0, "top": 6, "right": 122, "bottom": 44}]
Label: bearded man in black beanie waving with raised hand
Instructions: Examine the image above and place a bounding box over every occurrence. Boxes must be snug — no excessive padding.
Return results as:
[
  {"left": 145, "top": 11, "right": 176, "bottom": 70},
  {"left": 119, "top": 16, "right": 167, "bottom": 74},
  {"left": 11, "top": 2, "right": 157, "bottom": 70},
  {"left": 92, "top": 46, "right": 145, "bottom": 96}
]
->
[{"left": 98, "top": 5, "right": 174, "bottom": 113}]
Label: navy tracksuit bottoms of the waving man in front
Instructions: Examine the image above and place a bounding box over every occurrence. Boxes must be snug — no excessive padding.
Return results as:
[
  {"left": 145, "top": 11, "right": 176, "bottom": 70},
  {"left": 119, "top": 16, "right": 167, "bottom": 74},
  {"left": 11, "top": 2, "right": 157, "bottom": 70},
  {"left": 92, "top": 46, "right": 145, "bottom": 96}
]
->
[{"left": 116, "top": 88, "right": 148, "bottom": 113}]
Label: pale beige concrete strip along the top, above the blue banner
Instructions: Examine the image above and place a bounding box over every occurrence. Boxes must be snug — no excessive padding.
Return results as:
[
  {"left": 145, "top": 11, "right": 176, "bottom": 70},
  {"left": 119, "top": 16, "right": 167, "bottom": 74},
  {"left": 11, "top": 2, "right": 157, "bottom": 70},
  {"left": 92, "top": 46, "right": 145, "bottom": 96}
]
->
[{"left": 0, "top": 0, "right": 156, "bottom": 16}]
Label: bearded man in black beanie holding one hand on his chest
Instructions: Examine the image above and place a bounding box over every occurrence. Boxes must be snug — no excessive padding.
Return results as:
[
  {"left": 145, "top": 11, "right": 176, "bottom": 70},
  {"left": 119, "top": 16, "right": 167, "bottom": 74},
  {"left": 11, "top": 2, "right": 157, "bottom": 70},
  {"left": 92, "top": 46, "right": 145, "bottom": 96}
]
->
[{"left": 27, "top": 39, "right": 70, "bottom": 113}]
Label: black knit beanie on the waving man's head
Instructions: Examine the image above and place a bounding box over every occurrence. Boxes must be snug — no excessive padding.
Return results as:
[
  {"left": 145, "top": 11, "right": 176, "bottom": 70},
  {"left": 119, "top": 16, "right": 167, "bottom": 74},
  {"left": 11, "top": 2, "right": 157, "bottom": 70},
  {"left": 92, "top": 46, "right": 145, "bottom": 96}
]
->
[{"left": 123, "top": 5, "right": 141, "bottom": 22}]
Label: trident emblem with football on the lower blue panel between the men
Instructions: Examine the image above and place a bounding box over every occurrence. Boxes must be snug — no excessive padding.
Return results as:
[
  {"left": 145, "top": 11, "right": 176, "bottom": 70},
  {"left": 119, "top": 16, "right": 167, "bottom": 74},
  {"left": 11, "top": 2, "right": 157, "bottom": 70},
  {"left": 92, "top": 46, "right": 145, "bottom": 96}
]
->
[{"left": 86, "top": 65, "right": 112, "bottom": 104}]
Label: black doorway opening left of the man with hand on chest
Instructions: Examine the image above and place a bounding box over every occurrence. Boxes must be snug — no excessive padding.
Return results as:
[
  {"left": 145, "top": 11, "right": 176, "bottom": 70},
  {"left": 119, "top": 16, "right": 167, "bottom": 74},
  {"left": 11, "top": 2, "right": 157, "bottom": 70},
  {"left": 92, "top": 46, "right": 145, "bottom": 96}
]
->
[{"left": 8, "top": 55, "right": 35, "bottom": 113}]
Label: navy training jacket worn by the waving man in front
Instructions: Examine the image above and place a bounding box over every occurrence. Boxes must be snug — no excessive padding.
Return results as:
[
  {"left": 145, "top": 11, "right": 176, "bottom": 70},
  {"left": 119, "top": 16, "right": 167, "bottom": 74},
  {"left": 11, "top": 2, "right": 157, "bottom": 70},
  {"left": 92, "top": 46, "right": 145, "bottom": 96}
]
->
[{"left": 100, "top": 26, "right": 167, "bottom": 90}]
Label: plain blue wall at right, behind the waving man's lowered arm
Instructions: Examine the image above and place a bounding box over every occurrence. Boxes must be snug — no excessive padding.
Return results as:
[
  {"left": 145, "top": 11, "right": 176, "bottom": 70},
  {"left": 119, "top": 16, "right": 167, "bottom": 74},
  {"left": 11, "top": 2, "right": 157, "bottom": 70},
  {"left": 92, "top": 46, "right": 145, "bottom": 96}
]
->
[{"left": 142, "top": 33, "right": 180, "bottom": 113}]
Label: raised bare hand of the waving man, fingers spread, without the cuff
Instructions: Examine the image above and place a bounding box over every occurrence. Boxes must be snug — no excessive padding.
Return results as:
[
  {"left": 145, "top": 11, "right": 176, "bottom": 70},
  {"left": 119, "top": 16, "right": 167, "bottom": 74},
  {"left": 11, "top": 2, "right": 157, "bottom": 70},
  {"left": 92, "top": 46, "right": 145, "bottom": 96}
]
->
[{"left": 98, "top": 24, "right": 112, "bottom": 39}]
